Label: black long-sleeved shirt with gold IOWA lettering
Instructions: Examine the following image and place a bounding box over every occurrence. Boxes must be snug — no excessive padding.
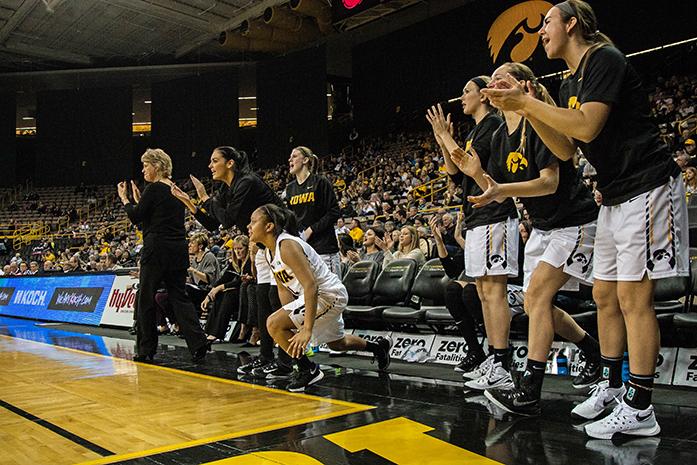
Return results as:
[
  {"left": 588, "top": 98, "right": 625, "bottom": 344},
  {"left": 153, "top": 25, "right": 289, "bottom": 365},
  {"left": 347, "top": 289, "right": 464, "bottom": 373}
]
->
[{"left": 286, "top": 174, "right": 341, "bottom": 254}]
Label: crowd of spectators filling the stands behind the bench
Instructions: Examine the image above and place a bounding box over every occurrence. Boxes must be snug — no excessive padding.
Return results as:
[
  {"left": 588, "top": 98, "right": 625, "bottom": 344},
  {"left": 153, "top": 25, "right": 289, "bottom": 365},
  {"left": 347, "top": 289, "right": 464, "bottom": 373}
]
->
[{"left": 0, "top": 70, "right": 697, "bottom": 337}]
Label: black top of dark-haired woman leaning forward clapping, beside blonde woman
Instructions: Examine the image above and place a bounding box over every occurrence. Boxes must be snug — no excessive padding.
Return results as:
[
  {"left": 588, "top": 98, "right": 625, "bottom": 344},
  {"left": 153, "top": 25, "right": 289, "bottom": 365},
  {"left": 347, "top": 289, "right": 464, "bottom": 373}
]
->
[{"left": 194, "top": 172, "right": 283, "bottom": 234}]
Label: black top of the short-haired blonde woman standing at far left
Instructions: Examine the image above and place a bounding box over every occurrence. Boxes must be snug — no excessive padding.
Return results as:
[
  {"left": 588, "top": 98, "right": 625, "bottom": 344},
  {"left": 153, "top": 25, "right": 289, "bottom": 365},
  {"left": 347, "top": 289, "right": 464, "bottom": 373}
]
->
[{"left": 124, "top": 182, "right": 189, "bottom": 269}]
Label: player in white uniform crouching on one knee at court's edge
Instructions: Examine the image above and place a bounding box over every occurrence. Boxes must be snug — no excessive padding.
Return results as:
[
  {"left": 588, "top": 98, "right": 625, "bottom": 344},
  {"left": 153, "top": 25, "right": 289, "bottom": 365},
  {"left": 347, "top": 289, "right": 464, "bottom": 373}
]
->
[{"left": 248, "top": 204, "right": 391, "bottom": 392}]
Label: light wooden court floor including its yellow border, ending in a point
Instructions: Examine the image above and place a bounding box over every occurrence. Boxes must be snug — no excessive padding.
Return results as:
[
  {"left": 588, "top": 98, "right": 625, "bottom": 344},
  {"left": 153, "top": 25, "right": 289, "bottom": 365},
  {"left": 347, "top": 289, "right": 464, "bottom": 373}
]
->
[{"left": 0, "top": 336, "right": 372, "bottom": 465}]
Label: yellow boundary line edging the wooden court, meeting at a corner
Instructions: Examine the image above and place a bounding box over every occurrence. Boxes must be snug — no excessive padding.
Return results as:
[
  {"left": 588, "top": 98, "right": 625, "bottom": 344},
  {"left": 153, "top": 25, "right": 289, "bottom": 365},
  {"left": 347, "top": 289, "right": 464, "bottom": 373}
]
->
[{"left": 0, "top": 334, "right": 376, "bottom": 465}]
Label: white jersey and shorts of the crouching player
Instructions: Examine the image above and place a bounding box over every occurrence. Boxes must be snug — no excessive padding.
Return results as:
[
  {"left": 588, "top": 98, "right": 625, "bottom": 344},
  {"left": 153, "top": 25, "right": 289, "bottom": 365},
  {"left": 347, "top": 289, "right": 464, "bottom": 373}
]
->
[{"left": 265, "top": 232, "right": 348, "bottom": 345}]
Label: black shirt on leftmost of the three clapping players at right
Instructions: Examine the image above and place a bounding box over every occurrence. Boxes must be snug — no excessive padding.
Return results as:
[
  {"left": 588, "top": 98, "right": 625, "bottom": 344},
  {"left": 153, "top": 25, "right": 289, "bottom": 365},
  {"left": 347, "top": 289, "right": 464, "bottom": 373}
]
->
[{"left": 450, "top": 112, "right": 516, "bottom": 230}]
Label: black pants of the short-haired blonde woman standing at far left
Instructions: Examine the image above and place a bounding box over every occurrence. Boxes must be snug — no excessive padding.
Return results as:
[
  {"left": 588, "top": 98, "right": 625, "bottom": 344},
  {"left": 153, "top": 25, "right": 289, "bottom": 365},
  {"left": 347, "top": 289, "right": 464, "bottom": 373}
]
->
[{"left": 136, "top": 261, "right": 206, "bottom": 356}]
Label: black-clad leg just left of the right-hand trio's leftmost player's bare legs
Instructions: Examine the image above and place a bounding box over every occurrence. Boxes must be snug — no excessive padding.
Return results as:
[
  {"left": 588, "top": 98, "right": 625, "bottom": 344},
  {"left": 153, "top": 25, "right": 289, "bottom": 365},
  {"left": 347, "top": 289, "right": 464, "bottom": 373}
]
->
[{"left": 445, "top": 281, "right": 484, "bottom": 350}]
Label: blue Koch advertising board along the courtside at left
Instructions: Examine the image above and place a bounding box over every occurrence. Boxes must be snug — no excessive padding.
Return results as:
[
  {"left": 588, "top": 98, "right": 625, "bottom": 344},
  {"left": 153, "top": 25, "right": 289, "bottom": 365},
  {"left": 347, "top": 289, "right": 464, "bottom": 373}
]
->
[{"left": 0, "top": 274, "right": 114, "bottom": 326}]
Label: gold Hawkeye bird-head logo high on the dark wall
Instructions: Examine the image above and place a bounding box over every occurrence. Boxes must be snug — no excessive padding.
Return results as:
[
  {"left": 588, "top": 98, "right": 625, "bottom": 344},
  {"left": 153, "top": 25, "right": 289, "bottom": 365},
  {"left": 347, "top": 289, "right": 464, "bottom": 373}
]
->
[{"left": 487, "top": 0, "right": 552, "bottom": 63}]
